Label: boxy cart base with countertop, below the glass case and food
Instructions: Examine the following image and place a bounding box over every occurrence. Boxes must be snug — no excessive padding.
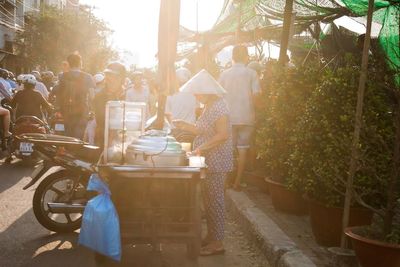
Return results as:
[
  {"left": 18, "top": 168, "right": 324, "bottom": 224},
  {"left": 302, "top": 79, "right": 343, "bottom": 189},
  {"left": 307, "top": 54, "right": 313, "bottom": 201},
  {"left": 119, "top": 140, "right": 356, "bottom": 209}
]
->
[{"left": 99, "top": 165, "right": 205, "bottom": 259}]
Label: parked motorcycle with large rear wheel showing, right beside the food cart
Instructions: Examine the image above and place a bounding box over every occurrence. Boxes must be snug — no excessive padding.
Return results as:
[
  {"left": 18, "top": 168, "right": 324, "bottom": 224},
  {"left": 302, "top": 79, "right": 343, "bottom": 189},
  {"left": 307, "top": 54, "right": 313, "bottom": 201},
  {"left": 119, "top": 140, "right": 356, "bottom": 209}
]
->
[{"left": 17, "top": 134, "right": 101, "bottom": 233}]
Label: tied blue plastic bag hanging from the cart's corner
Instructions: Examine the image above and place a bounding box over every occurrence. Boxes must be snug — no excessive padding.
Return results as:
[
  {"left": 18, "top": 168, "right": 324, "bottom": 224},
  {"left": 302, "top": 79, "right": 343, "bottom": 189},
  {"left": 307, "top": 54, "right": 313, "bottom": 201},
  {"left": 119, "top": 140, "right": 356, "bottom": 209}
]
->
[{"left": 78, "top": 174, "right": 121, "bottom": 261}]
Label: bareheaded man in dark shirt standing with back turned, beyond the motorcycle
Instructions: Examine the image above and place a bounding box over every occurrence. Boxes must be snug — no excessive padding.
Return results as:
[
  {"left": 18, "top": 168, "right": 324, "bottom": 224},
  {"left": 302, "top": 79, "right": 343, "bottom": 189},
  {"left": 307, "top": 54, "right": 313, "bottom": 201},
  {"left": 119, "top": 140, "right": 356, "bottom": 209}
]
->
[{"left": 56, "top": 53, "right": 95, "bottom": 139}]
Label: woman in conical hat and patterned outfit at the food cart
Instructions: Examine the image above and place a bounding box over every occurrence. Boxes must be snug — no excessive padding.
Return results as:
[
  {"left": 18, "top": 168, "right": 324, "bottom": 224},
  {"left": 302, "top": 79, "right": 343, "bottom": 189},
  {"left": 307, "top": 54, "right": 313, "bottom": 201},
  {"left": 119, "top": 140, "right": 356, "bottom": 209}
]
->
[{"left": 173, "top": 70, "right": 233, "bottom": 256}]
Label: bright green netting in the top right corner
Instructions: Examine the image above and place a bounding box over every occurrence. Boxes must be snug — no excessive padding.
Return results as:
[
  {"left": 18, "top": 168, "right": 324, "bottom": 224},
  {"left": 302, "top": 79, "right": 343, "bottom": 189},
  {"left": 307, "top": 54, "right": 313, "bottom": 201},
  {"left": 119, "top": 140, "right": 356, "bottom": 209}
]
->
[{"left": 342, "top": 0, "right": 400, "bottom": 86}]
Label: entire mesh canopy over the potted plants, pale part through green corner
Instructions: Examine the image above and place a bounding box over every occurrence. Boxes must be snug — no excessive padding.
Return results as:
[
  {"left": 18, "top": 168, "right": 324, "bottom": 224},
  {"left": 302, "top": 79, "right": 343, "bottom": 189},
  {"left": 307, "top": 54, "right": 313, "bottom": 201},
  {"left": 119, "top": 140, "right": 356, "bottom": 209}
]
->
[{"left": 180, "top": 0, "right": 400, "bottom": 84}]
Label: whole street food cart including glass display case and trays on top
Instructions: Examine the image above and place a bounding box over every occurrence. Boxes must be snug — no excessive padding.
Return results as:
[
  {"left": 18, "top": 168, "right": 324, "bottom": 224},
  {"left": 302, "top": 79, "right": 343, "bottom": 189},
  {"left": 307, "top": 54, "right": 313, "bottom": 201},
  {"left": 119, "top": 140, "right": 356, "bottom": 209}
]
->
[{"left": 96, "top": 102, "right": 202, "bottom": 261}]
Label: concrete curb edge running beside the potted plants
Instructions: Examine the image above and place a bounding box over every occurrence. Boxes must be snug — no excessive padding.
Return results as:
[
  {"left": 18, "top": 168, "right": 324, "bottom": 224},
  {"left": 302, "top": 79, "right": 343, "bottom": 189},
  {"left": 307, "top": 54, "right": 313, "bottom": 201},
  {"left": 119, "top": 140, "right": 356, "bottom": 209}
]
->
[{"left": 225, "top": 190, "right": 316, "bottom": 267}]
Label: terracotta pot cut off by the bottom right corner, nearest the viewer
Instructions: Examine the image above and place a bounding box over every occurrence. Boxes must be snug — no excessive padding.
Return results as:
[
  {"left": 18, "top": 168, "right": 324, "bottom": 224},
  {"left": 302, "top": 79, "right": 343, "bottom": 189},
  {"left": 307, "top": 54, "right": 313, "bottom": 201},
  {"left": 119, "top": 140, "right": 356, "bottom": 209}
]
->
[{"left": 345, "top": 227, "right": 400, "bottom": 267}]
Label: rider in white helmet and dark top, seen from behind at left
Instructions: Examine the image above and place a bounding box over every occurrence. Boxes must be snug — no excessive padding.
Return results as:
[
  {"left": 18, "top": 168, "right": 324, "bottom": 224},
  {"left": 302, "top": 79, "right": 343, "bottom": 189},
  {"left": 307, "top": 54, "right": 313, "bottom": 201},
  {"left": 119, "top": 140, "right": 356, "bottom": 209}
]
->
[{"left": 11, "top": 74, "right": 52, "bottom": 119}]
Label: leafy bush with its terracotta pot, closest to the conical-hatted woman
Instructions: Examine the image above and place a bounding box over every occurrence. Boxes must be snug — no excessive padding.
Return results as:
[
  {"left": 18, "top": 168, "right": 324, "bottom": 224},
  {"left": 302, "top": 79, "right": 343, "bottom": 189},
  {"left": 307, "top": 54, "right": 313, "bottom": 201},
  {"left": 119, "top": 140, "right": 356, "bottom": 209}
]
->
[{"left": 256, "top": 63, "right": 318, "bottom": 215}]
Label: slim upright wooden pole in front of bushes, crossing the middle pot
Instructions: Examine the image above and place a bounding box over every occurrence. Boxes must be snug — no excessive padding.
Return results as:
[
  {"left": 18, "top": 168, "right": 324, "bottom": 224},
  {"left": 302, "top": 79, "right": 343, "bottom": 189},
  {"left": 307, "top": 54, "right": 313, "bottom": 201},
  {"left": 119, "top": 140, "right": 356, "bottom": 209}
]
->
[{"left": 340, "top": 0, "right": 375, "bottom": 248}]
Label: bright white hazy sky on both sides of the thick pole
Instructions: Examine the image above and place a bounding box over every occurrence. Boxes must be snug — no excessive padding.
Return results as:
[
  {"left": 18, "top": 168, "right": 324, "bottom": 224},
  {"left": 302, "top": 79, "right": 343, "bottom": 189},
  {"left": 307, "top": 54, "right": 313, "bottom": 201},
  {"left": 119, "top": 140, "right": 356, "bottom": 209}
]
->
[{"left": 80, "top": 0, "right": 224, "bottom": 66}]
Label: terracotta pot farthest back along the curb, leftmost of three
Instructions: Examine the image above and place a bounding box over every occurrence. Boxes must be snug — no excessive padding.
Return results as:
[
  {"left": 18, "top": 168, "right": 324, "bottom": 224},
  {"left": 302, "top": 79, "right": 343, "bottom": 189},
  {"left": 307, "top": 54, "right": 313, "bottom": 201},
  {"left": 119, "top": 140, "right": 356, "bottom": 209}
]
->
[{"left": 265, "top": 178, "right": 307, "bottom": 215}]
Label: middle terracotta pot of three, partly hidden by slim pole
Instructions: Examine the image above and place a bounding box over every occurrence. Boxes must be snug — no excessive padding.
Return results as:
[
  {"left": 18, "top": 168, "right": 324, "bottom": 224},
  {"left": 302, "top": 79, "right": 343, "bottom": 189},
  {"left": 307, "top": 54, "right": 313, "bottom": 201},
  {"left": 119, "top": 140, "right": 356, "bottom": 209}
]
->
[{"left": 308, "top": 199, "right": 372, "bottom": 247}]
